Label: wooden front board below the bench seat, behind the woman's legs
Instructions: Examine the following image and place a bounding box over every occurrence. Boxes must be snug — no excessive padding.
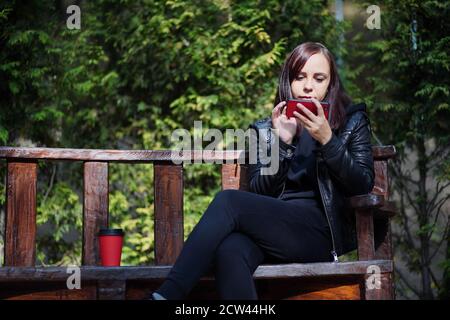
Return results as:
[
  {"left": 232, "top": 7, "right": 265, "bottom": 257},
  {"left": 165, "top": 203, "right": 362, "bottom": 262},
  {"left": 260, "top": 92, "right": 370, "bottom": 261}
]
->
[{"left": 0, "top": 276, "right": 364, "bottom": 301}]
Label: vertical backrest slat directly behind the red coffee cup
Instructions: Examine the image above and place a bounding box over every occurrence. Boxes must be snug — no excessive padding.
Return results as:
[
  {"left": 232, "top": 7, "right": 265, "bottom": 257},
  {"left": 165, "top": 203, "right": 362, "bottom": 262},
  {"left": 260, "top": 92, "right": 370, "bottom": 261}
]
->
[{"left": 82, "top": 162, "right": 109, "bottom": 265}]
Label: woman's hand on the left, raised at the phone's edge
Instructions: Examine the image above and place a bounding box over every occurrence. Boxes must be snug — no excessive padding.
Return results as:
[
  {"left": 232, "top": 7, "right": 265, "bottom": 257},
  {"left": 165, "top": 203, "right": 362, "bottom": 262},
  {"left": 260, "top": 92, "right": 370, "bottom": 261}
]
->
[{"left": 272, "top": 101, "right": 301, "bottom": 144}]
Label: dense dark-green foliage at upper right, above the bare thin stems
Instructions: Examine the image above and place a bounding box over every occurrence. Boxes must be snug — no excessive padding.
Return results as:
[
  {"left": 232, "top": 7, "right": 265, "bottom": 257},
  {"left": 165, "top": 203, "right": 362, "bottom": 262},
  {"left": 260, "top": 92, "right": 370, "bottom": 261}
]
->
[{"left": 348, "top": 1, "right": 450, "bottom": 155}]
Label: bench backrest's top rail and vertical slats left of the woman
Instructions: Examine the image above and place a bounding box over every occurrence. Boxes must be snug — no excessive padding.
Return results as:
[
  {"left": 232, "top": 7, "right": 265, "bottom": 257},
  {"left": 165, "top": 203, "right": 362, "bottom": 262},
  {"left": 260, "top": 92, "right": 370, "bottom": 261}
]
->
[{"left": 0, "top": 147, "right": 246, "bottom": 266}]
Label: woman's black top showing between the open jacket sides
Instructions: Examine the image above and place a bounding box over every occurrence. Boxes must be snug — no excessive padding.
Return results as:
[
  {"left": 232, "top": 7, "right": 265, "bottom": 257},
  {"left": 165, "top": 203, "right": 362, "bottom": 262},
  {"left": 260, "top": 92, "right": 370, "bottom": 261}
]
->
[{"left": 280, "top": 129, "right": 320, "bottom": 199}]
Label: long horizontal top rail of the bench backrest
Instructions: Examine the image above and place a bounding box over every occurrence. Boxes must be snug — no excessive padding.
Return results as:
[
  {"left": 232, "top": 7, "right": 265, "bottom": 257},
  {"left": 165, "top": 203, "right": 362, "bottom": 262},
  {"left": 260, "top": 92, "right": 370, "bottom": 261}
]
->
[{"left": 0, "top": 147, "right": 245, "bottom": 163}]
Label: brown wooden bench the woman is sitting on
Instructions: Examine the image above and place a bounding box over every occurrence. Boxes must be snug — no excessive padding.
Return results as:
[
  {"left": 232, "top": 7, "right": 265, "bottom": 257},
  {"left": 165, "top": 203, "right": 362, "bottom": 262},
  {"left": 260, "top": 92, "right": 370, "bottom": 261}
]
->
[{"left": 0, "top": 146, "right": 396, "bottom": 299}]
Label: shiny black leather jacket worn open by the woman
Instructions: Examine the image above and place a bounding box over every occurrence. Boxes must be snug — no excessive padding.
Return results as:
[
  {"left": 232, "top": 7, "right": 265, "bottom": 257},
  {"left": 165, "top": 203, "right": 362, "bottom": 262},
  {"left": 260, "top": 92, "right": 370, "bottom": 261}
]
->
[{"left": 249, "top": 103, "right": 375, "bottom": 262}]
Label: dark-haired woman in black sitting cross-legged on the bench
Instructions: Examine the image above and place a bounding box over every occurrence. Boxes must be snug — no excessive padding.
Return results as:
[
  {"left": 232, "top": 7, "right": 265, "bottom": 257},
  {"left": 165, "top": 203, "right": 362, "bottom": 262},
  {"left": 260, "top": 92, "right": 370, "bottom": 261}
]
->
[{"left": 151, "top": 42, "right": 374, "bottom": 300}]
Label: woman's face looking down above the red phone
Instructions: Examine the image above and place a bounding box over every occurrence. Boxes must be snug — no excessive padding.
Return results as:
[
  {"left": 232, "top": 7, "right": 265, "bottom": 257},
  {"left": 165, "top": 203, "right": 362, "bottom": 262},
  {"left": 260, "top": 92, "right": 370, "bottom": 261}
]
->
[{"left": 291, "top": 53, "right": 330, "bottom": 101}]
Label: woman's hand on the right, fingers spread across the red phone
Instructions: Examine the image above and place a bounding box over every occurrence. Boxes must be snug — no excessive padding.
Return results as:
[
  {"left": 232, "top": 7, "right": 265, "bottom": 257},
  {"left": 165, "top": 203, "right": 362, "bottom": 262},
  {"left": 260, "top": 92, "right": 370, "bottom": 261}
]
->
[{"left": 294, "top": 98, "right": 333, "bottom": 145}]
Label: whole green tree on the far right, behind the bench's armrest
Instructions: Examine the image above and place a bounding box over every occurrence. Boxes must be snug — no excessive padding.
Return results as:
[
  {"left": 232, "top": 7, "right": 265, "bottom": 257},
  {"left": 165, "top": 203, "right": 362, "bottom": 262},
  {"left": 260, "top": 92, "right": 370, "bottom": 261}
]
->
[{"left": 354, "top": 1, "right": 450, "bottom": 299}]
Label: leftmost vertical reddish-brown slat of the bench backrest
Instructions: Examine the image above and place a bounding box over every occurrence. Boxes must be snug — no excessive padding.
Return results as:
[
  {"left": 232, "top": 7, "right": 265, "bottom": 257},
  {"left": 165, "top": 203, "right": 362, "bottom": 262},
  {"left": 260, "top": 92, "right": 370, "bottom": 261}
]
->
[{"left": 5, "top": 161, "right": 37, "bottom": 266}]
